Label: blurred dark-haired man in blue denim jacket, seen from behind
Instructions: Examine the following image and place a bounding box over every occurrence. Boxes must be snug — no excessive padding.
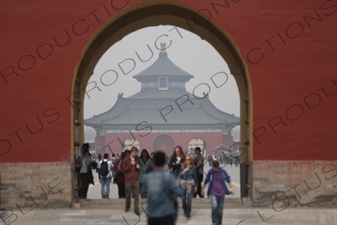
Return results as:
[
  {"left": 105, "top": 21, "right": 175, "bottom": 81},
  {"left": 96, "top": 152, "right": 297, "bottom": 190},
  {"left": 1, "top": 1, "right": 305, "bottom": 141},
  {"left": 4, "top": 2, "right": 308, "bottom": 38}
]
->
[{"left": 142, "top": 151, "right": 183, "bottom": 225}]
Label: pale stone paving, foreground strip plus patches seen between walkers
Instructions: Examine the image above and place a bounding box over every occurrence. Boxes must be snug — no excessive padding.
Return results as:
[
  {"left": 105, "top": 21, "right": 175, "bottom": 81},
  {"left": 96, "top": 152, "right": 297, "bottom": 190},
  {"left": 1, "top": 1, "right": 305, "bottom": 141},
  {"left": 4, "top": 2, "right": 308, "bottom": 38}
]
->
[{"left": 0, "top": 163, "right": 337, "bottom": 225}]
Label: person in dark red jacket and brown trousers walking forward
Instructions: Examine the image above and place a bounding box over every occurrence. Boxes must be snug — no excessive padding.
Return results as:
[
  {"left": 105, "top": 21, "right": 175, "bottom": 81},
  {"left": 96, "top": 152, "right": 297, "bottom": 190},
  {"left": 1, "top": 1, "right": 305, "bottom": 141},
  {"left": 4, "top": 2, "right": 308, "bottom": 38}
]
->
[{"left": 122, "top": 147, "right": 140, "bottom": 216}]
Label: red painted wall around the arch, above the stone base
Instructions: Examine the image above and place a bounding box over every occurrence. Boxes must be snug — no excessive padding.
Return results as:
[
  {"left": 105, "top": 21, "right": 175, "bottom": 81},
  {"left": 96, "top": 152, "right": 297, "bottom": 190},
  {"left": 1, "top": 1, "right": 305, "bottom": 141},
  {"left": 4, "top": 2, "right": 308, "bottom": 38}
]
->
[{"left": 0, "top": 0, "right": 337, "bottom": 162}]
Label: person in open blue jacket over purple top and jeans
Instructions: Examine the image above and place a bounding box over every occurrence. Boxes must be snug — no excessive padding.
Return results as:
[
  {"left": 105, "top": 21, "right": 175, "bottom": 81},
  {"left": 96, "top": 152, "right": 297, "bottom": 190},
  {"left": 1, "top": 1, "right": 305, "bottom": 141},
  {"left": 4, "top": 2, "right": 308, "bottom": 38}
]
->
[{"left": 201, "top": 161, "right": 234, "bottom": 225}]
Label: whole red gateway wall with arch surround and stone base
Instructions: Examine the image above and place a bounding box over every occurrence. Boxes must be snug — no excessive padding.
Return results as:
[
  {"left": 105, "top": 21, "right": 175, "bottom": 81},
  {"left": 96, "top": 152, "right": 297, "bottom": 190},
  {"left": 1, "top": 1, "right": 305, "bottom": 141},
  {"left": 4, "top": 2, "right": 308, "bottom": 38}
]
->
[{"left": 0, "top": 0, "right": 337, "bottom": 211}]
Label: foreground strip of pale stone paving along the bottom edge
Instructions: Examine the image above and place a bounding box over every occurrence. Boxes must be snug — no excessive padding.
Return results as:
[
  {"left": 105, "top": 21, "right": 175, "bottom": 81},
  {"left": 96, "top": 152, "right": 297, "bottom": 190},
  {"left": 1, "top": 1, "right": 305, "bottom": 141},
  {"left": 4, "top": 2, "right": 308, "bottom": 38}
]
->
[{"left": 0, "top": 206, "right": 337, "bottom": 225}]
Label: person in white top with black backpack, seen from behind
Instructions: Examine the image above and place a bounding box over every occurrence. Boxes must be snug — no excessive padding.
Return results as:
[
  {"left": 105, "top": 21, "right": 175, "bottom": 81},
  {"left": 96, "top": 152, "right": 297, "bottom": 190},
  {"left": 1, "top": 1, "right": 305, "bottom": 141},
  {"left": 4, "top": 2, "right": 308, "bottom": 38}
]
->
[{"left": 97, "top": 153, "right": 113, "bottom": 199}]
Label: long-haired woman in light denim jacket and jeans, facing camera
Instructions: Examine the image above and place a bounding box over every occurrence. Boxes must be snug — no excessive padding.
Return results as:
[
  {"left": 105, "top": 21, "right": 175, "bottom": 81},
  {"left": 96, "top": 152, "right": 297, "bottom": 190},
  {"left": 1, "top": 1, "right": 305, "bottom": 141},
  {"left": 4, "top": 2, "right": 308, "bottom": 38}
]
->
[{"left": 178, "top": 154, "right": 198, "bottom": 220}]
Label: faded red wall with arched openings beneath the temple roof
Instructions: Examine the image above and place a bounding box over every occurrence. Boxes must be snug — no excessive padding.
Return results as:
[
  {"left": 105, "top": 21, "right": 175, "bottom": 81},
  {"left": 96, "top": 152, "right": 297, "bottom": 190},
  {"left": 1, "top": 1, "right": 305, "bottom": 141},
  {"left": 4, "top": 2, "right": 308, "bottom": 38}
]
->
[{"left": 105, "top": 132, "right": 222, "bottom": 155}]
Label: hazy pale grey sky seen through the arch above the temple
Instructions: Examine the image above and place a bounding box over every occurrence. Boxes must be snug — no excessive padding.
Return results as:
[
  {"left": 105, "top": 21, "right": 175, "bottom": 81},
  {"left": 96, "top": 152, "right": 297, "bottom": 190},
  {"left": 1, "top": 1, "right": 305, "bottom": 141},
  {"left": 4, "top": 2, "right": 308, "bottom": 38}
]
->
[{"left": 84, "top": 26, "right": 240, "bottom": 136}]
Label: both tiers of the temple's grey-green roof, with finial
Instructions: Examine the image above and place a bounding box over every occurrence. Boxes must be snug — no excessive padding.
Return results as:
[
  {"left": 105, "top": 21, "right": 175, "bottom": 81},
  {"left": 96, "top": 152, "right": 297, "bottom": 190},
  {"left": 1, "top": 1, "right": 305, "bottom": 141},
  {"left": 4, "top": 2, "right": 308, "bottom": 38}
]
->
[{"left": 85, "top": 43, "right": 240, "bottom": 129}]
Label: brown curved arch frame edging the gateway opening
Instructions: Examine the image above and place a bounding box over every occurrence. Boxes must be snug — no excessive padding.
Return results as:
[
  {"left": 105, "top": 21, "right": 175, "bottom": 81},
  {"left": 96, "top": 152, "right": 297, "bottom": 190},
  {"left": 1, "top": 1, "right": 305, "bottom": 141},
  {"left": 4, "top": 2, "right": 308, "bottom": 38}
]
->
[{"left": 70, "top": 0, "right": 253, "bottom": 197}]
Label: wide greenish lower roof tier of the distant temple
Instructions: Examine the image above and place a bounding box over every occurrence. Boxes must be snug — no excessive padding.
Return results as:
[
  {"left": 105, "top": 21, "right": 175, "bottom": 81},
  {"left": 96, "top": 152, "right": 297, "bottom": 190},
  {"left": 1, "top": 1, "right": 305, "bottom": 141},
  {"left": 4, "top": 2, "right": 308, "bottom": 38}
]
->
[{"left": 85, "top": 96, "right": 240, "bottom": 127}]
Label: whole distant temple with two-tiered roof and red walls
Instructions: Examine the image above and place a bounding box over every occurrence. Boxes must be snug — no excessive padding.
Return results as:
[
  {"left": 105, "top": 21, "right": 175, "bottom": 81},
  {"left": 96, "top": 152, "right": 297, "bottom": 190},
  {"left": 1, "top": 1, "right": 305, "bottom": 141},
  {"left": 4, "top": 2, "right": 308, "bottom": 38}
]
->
[{"left": 85, "top": 42, "right": 240, "bottom": 155}]
